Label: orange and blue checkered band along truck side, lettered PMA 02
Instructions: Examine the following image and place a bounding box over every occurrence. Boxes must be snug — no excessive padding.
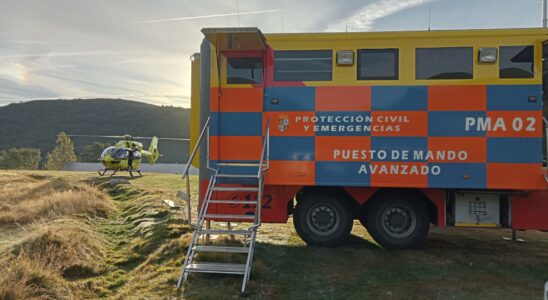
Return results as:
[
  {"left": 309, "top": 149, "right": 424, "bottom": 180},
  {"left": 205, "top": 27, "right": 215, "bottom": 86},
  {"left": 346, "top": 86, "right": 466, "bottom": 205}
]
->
[{"left": 210, "top": 85, "right": 545, "bottom": 189}]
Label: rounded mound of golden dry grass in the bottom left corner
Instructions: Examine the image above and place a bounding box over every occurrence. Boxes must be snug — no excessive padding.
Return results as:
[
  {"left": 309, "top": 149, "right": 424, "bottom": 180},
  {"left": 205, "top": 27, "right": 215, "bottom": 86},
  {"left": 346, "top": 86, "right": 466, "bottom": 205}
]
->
[{"left": 0, "top": 224, "right": 108, "bottom": 299}]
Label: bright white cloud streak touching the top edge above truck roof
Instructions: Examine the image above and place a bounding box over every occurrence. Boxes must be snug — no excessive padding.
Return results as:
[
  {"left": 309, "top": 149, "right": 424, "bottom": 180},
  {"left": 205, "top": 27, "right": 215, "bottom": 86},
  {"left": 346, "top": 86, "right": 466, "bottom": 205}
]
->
[{"left": 326, "top": 0, "right": 433, "bottom": 31}]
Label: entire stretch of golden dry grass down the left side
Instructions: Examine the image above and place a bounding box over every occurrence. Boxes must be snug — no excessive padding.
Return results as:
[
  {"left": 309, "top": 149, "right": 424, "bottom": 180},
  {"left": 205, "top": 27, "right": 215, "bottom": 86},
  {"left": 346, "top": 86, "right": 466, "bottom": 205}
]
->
[{"left": 0, "top": 173, "right": 114, "bottom": 299}]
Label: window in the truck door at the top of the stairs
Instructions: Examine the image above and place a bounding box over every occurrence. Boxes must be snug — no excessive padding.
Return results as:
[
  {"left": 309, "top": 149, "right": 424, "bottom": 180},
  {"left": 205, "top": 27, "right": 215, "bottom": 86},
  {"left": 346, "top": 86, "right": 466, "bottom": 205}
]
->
[{"left": 226, "top": 57, "right": 263, "bottom": 84}]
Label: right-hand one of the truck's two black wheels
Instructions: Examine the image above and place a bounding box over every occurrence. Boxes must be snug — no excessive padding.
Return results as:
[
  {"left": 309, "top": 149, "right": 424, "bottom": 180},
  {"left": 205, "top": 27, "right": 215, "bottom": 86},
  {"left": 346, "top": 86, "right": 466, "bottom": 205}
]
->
[{"left": 364, "top": 194, "right": 430, "bottom": 249}]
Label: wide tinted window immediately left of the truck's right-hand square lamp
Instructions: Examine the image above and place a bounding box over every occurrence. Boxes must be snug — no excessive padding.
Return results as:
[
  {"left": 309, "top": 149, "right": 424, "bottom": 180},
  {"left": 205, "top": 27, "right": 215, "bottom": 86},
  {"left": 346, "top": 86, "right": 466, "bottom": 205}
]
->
[{"left": 415, "top": 47, "right": 474, "bottom": 79}]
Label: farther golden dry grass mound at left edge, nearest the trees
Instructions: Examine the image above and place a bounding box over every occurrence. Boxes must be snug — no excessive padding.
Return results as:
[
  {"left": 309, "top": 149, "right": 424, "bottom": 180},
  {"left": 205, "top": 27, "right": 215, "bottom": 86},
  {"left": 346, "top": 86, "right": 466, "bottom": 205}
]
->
[{"left": 0, "top": 177, "right": 112, "bottom": 225}]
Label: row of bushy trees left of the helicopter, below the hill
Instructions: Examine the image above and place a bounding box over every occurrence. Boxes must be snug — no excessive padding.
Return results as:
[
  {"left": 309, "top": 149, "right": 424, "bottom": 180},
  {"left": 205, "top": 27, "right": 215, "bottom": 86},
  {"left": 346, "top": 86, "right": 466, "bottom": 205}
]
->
[{"left": 0, "top": 132, "right": 103, "bottom": 170}]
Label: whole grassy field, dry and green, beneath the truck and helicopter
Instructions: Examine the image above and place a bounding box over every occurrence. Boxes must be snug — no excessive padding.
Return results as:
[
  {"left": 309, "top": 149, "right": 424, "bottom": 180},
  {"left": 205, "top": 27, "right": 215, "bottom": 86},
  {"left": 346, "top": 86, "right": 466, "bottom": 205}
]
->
[{"left": 0, "top": 171, "right": 548, "bottom": 299}]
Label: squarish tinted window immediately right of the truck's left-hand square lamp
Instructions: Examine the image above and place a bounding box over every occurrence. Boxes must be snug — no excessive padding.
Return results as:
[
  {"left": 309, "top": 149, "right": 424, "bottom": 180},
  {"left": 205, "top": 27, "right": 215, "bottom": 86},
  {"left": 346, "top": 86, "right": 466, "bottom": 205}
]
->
[{"left": 358, "top": 49, "right": 398, "bottom": 80}]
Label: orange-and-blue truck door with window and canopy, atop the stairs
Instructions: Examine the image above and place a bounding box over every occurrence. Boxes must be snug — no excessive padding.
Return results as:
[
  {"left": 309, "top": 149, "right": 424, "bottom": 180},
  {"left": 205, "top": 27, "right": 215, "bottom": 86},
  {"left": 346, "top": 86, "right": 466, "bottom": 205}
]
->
[{"left": 202, "top": 28, "right": 266, "bottom": 169}]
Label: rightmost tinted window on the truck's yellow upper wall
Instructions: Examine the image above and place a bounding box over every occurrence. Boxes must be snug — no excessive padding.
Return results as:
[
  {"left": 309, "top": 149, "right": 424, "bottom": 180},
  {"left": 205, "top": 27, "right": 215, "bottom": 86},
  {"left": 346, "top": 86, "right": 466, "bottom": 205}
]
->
[{"left": 499, "top": 46, "right": 535, "bottom": 78}]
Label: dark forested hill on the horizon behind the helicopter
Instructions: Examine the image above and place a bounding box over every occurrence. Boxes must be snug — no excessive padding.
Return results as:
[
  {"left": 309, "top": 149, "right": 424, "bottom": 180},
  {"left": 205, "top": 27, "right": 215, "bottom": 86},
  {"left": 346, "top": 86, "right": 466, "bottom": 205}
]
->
[{"left": 0, "top": 99, "right": 190, "bottom": 163}]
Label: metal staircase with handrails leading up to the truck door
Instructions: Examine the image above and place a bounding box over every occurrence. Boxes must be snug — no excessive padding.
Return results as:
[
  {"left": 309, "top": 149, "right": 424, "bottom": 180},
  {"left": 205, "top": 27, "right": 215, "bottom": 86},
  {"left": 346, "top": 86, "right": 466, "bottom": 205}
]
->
[{"left": 177, "top": 118, "right": 270, "bottom": 293}]
